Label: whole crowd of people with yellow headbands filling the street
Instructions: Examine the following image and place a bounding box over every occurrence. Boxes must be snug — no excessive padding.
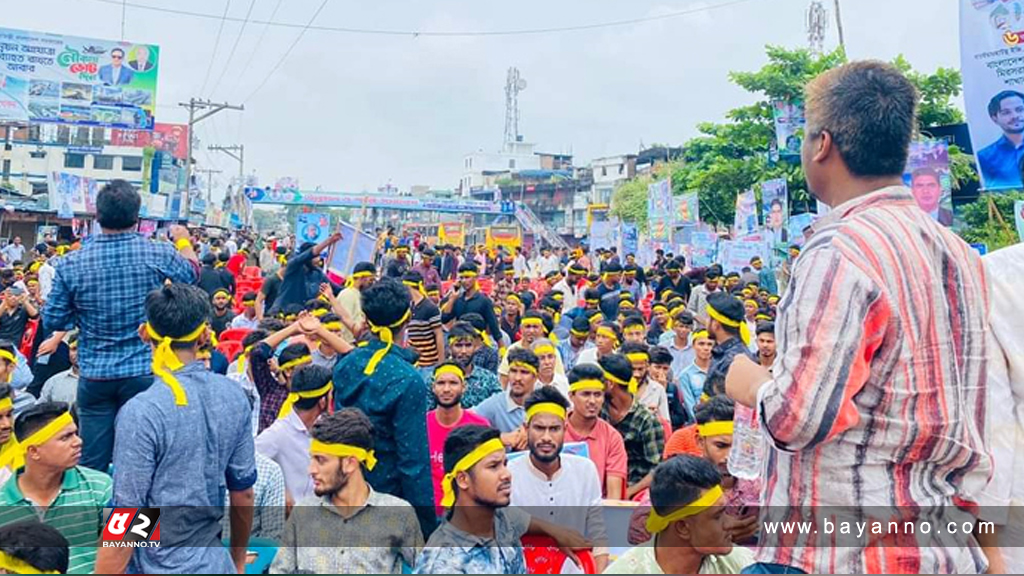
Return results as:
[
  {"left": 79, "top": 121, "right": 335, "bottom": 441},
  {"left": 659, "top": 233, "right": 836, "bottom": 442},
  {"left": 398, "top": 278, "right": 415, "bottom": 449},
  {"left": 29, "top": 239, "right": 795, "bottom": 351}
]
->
[{"left": 0, "top": 63, "right": 1024, "bottom": 574}]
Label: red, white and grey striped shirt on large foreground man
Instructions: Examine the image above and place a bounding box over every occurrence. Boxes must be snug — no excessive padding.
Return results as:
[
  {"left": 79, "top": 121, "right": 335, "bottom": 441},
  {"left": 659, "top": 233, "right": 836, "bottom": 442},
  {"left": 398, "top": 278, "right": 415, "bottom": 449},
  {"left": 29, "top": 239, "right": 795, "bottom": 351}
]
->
[{"left": 758, "top": 187, "right": 991, "bottom": 572}]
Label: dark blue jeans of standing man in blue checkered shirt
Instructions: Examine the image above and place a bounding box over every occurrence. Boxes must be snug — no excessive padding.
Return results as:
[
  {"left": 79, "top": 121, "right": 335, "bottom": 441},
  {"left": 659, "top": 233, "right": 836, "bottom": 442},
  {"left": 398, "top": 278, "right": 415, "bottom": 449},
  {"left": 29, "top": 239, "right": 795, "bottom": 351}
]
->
[{"left": 75, "top": 375, "right": 153, "bottom": 472}]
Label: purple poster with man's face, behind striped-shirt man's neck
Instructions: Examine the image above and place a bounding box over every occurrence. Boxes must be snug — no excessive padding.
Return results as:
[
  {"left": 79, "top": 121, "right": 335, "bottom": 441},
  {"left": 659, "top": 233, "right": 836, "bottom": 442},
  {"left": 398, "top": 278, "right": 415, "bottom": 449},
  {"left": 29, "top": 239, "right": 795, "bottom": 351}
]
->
[{"left": 903, "top": 140, "right": 953, "bottom": 227}]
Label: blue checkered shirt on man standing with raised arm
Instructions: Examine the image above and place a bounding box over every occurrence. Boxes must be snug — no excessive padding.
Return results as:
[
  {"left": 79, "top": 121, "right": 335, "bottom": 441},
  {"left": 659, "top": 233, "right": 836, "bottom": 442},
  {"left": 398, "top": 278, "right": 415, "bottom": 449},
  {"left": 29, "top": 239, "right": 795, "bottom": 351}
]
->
[{"left": 43, "top": 233, "right": 199, "bottom": 380}]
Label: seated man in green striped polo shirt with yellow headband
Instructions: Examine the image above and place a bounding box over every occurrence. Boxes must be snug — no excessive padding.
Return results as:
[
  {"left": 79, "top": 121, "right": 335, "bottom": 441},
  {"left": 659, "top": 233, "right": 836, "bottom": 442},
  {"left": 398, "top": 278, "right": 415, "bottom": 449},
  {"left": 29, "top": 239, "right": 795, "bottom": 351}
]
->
[{"left": 0, "top": 402, "right": 114, "bottom": 574}]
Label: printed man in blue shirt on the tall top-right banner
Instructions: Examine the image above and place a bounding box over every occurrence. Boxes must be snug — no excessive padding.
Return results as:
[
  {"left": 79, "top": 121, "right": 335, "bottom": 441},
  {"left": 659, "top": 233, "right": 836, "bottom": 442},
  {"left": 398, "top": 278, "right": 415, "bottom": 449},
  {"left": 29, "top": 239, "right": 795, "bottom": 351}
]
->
[{"left": 978, "top": 90, "right": 1024, "bottom": 190}]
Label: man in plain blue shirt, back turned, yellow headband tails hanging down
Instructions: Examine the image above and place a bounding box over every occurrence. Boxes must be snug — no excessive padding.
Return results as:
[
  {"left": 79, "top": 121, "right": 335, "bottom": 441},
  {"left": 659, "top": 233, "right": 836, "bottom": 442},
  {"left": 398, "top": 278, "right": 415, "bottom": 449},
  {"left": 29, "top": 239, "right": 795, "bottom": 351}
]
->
[{"left": 96, "top": 284, "right": 254, "bottom": 574}]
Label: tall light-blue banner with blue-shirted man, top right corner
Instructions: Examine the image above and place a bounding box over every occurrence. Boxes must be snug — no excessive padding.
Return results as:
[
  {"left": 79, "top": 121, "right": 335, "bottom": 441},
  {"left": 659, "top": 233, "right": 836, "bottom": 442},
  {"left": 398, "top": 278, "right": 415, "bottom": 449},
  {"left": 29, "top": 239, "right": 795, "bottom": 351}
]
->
[{"left": 959, "top": 0, "right": 1024, "bottom": 191}]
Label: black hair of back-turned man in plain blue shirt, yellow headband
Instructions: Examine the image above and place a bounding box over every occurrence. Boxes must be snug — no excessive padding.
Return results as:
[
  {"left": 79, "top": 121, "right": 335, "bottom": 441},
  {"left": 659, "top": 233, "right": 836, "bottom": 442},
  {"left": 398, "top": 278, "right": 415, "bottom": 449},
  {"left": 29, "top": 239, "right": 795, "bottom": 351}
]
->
[{"left": 145, "top": 284, "right": 210, "bottom": 348}]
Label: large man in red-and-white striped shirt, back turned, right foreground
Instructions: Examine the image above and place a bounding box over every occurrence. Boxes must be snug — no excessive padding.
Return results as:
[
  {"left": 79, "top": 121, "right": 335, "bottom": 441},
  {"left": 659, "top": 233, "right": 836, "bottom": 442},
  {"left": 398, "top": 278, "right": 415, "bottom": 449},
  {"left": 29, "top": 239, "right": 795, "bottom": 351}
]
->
[{"left": 726, "top": 61, "right": 991, "bottom": 574}]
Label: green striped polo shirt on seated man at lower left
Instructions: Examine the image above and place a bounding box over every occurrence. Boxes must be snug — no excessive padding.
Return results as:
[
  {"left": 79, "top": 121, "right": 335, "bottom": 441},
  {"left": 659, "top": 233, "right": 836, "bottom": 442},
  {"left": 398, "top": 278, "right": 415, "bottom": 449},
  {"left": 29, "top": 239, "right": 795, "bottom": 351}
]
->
[{"left": 0, "top": 466, "right": 114, "bottom": 574}]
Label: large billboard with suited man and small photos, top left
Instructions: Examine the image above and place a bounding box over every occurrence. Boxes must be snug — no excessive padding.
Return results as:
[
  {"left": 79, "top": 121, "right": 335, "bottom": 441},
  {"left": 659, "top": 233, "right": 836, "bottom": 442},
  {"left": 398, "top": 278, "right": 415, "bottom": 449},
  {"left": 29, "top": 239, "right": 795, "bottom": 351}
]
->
[{"left": 0, "top": 28, "right": 160, "bottom": 129}]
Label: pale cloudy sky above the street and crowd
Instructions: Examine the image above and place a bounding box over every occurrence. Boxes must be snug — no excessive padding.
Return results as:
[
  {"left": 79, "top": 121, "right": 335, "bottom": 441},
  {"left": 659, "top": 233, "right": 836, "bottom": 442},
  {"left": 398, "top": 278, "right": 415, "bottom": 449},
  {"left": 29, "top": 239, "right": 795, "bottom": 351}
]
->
[{"left": 12, "top": 0, "right": 959, "bottom": 191}]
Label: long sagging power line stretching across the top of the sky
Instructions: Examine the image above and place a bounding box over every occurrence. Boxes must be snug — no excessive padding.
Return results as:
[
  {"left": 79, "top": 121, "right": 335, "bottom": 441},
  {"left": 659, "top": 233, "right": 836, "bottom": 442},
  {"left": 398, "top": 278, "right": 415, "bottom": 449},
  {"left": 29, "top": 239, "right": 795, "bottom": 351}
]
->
[{"left": 90, "top": 0, "right": 758, "bottom": 38}]
